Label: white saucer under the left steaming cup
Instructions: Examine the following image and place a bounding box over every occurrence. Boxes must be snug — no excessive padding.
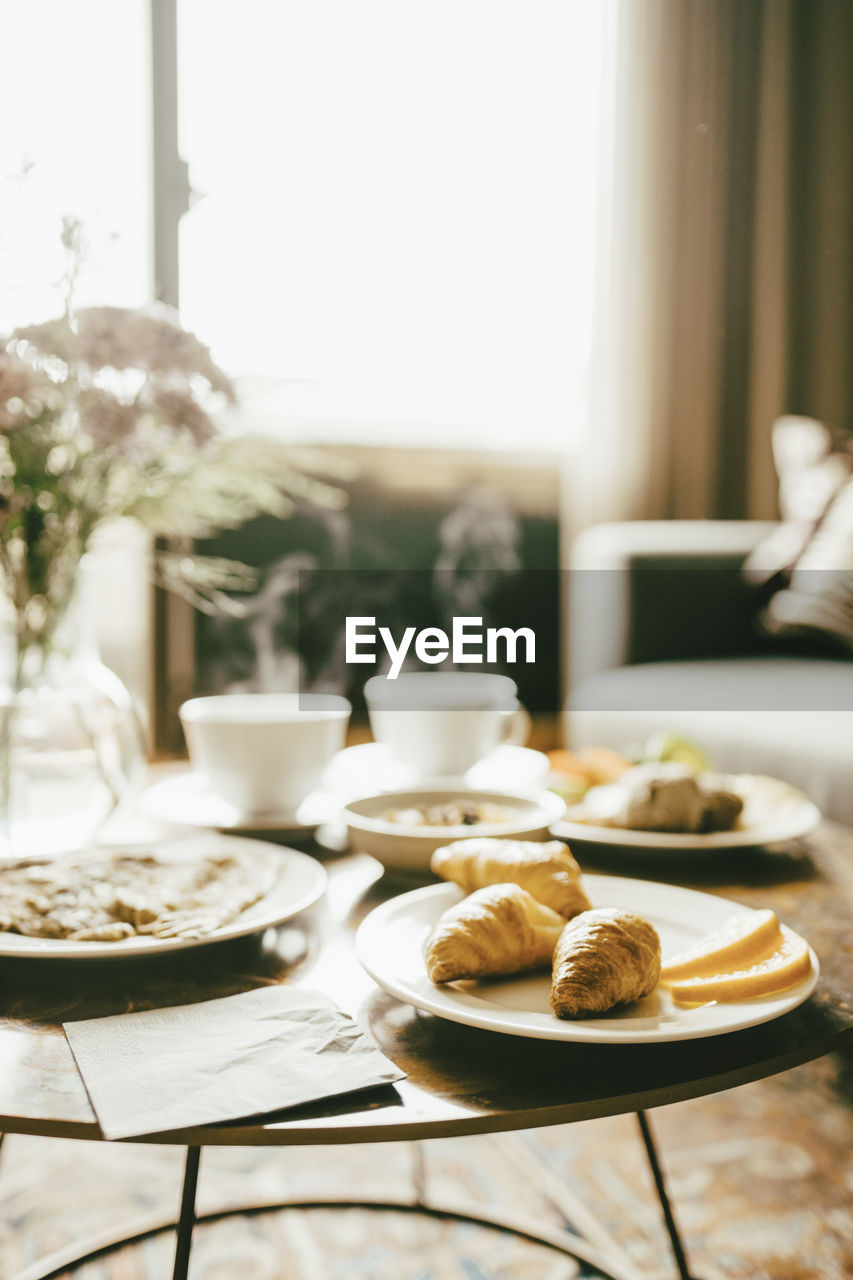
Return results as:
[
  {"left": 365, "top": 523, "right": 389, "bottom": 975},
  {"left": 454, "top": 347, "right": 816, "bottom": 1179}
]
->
[{"left": 138, "top": 771, "right": 343, "bottom": 835}]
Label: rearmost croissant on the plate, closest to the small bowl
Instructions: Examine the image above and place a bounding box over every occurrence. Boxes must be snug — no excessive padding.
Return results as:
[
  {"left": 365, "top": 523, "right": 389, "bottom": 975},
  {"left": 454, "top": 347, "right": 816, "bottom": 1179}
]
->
[{"left": 430, "top": 836, "right": 590, "bottom": 919}]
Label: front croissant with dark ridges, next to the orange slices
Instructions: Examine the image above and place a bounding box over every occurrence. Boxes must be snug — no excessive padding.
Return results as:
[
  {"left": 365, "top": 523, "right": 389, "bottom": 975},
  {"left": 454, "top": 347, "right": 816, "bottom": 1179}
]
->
[{"left": 551, "top": 906, "right": 661, "bottom": 1018}]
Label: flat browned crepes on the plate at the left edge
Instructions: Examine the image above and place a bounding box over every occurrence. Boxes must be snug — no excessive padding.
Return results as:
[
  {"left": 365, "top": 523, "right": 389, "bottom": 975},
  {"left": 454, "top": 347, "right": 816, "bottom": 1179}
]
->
[{"left": 0, "top": 849, "right": 277, "bottom": 942}]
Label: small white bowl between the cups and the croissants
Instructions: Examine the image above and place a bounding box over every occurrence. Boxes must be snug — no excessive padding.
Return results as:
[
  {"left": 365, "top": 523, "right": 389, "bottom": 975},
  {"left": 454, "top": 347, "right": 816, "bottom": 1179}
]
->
[{"left": 342, "top": 787, "right": 566, "bottom": 872}]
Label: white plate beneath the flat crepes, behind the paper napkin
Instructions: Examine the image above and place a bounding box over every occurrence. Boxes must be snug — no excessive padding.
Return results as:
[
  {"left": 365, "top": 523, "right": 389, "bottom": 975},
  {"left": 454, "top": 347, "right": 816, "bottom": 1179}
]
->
[{"left": 0, "top": 836, "right": 327, "bottom": 960}]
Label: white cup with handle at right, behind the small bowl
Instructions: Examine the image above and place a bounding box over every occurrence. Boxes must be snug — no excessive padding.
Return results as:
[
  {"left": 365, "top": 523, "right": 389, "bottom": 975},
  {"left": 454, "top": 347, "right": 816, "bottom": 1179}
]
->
[{"left": 364, "top": 671, "right": 528, "bottom": 777}]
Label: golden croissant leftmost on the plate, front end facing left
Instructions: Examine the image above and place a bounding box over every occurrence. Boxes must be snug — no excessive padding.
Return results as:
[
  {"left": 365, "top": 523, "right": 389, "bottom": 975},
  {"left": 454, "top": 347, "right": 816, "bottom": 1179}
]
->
[{"left": 424, "top": 884, "right": 566, "bottom": 983}]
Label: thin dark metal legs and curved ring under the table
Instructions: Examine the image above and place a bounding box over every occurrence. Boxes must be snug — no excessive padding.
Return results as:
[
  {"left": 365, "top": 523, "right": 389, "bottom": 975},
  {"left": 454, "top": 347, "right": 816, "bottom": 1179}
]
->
[{"left": 0, "top": 1111, "right": 695, "bottom": 1280}]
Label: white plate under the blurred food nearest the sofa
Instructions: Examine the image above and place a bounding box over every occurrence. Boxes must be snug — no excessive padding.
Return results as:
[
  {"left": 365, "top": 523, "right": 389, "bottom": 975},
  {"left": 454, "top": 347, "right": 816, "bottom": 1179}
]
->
[{"left": 551, "top": 773, "right": 821, "bottom": 851}]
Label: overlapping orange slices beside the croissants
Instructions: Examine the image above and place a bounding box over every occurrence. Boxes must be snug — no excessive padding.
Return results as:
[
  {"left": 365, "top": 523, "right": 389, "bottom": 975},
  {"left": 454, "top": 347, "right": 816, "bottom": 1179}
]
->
[{"left": 661, "top": 911, "right": 812, "bottom": 1004}]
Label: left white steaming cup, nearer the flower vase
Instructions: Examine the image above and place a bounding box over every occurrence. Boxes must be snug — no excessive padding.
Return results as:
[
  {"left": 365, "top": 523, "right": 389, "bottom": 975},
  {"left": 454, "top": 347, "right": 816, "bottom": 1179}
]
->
[{"left": 178, "top": 694, "right": 352, "bottom": 815}]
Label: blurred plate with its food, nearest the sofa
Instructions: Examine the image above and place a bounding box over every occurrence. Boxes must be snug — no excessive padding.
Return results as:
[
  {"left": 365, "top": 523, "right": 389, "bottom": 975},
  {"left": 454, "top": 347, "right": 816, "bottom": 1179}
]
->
[{"left": 549, "top": 740, "right": 821, "bottom": 851}]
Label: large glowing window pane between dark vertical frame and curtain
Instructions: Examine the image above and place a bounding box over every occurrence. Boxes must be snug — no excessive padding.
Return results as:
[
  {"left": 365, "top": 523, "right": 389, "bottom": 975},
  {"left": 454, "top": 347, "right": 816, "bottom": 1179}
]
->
[{"left": 178, "top": 0, "right": 607, "bottom": 449}]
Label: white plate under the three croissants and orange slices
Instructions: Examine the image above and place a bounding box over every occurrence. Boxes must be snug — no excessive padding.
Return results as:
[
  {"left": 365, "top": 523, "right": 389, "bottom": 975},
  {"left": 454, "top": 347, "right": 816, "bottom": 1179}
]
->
[{"left": 357, "top": 876, "right": 818, "bottom": 1044}]
